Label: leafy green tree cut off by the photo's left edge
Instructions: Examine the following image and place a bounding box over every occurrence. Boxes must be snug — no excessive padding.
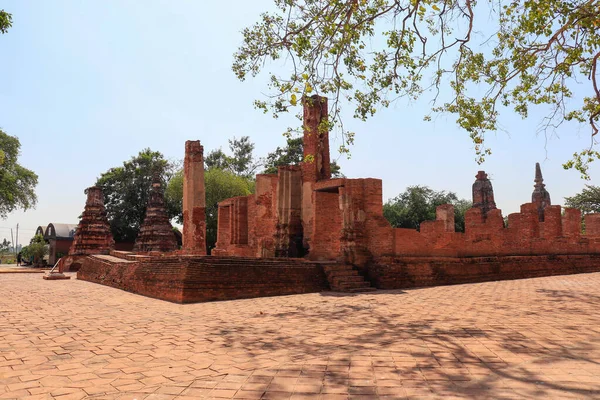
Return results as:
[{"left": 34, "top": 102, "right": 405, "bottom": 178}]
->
[{"left": 0, "top": 130, "right": 38, "bottom": 219}]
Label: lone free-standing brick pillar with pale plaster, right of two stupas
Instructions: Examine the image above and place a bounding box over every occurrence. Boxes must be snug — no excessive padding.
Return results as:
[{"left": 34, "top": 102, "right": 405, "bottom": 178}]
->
[{"left": 183, "top": 140, "right": 206, "bottom": 254}]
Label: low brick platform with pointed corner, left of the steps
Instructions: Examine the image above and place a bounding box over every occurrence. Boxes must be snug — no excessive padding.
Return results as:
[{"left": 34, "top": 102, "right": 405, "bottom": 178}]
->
[{"left": 77, "top": 257, "right": 329, "bottom": 303}]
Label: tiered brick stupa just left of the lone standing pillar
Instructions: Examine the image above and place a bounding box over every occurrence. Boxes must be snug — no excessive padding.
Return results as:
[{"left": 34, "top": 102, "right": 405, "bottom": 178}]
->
[{"left": 133, "top": 174, "right": 177, "bottom": 252}]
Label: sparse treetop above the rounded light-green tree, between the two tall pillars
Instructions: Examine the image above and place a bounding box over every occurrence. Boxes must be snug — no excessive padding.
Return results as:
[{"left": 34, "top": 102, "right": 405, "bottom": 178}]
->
[{"left": 204, "top": 136, "right": 259, "bottom": 178}]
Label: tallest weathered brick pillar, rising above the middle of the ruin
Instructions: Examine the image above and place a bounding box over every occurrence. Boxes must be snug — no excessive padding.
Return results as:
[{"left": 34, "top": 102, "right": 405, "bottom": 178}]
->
[{"left": 302, "top": 95, "right": 331, "bottom": 251}]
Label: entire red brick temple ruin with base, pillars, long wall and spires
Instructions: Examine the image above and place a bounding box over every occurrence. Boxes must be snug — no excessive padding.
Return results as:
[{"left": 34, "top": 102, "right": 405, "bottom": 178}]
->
[{"left": 78, "top": 96, "right": 600, "bottom": 303}]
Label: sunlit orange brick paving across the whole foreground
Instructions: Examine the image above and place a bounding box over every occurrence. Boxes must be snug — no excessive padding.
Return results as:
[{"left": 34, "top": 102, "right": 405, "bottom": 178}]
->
[{"left": 0, "top": 274, "right": 600, "bottom": 400}]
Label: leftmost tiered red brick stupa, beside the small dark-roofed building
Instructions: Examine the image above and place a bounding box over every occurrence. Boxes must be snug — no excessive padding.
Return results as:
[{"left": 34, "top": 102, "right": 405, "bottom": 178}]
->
[{"left": 60, "top": 186, "right": 115, "bottom": 272}]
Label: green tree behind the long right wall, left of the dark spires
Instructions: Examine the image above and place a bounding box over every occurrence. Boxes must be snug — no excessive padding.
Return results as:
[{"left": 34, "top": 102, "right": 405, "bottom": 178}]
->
[{"left": 383, "top": 186, "right": 472, "bottom": 232}]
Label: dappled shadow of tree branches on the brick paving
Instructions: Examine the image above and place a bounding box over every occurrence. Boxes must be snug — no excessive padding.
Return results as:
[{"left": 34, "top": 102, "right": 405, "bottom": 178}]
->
[{"left": 203, "top": 289, "right": 600, "bottom": 398}]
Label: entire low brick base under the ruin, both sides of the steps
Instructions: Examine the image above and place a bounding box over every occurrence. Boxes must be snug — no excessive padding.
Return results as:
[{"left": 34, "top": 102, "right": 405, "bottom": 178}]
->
[{"left": 77, "top": 251, "right": 600, "bottom": 304}]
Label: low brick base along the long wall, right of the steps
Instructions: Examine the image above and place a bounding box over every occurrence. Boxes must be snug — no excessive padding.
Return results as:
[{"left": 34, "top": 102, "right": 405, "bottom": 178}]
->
[{"left": 366, "top": 254, "right": 600, "bottom": 289}]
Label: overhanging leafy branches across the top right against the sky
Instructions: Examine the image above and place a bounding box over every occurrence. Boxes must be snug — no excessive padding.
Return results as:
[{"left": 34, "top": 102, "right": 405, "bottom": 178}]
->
[{"left": 233, "top": 0, "right": 600, "bottom": 177}]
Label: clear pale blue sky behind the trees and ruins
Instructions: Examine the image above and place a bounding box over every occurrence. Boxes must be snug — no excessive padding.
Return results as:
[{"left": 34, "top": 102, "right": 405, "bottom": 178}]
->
[{"left": 0, "top": 0, "right": 600, "bottom": 243}]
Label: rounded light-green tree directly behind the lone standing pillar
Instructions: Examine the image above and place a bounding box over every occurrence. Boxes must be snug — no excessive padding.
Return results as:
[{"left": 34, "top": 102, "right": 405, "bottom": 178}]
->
[{"left": 165, "top": 168, "right": 254, "bottom": 251}]
